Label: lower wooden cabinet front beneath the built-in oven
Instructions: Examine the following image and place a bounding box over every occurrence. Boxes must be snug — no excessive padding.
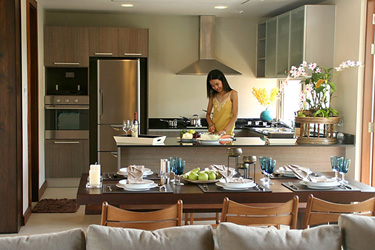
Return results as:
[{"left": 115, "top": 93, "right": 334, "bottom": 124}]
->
[{"left": 45, "top": 139, "right": 89, "bottom": 178}]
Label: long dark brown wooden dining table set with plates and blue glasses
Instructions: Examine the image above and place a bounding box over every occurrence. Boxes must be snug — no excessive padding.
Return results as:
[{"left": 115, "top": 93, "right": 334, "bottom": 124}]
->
[{"left": 76, "top": 172, "right": 375, "bottom": 225}]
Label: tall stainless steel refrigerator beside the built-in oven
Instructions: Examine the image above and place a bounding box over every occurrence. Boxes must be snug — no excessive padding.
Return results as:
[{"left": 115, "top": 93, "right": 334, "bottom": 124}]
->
[{"left": 97, "top": 59, "right": 142, "bottom": 172}]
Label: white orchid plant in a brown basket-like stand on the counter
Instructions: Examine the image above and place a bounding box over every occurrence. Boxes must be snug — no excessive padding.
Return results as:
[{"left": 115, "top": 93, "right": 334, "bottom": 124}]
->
[{"left": 285, "top": 61, "right": 362, "bottom": 144}]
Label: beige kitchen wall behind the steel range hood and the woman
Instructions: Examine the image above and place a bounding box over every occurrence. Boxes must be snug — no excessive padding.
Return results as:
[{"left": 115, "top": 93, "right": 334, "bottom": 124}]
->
[{"left": 45, "top": 12, "right": 276, "bottom": 117}]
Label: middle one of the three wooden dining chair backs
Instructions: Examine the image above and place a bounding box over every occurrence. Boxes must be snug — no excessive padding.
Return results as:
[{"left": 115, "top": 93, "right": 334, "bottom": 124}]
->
[{"left": 220, "top": 195, "right": 299, "bottom": 229}]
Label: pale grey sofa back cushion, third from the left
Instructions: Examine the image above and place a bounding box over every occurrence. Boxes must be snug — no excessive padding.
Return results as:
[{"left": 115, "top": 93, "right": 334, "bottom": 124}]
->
[{"left": 217, "top": 222, "right": 341, "bottom": 250}]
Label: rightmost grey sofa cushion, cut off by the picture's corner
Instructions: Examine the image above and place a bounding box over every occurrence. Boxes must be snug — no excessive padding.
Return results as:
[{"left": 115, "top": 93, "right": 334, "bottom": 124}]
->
[{"left": 339, "top": 214, "right": 375, "bottom": 250}]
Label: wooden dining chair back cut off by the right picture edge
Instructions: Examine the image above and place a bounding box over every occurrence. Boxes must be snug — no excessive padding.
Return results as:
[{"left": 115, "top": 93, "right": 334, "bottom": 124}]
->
[{"left": 303, "top": 194, "right": 375, "bottom": 228}]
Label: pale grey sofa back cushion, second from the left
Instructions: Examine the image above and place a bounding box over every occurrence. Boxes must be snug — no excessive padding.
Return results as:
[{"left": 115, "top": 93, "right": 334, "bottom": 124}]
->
[{"left": 86, "top": 225, "right": 214, "bottom": 250}]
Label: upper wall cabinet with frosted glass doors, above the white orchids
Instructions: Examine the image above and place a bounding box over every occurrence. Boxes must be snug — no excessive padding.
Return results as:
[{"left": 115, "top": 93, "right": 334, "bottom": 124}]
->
[{"left": 257, "top": 5, "right": 335, "bottom": 77}]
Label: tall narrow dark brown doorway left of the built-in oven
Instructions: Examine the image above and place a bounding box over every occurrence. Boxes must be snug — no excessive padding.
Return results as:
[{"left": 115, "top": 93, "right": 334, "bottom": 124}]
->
[{"left": 27, "top": 0, "right": 40, "bottom": 202}]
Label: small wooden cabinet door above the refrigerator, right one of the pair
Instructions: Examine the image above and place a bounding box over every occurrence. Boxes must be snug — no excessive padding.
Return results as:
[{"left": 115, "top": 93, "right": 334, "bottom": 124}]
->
[{"left": 119, "top": 28, "right": 148, "bottom": 57}]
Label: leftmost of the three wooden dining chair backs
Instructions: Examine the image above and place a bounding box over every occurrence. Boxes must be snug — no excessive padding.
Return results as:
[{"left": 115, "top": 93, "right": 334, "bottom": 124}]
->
[{"left": 100, "top": 200, "right": 183, "bottom": 230}]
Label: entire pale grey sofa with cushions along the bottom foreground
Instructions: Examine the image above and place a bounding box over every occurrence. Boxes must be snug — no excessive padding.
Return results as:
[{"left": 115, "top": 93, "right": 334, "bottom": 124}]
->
[{"left": 0, "top": 215, "right": 375, "bottom": 250}]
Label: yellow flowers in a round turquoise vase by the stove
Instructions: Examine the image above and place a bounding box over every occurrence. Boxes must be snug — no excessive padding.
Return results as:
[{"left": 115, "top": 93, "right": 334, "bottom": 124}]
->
[{"left": 251, "top": 88, "right": 280, "bottom": 122}]
